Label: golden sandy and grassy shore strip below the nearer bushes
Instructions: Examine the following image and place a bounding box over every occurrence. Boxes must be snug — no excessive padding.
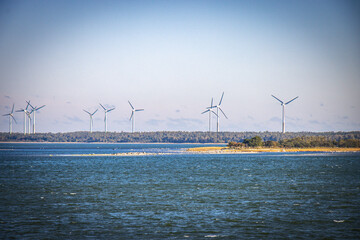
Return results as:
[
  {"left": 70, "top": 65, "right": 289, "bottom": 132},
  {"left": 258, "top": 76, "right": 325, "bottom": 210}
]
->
[{"left": 187, "top": 147, "right": 360, "bottom": 154}]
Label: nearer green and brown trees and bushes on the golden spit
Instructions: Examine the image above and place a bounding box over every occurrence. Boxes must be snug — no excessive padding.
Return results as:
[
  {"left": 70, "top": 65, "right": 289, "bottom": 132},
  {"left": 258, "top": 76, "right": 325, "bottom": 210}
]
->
[{"left": 228, "top": 136, "right": 360, "bottom": 148}]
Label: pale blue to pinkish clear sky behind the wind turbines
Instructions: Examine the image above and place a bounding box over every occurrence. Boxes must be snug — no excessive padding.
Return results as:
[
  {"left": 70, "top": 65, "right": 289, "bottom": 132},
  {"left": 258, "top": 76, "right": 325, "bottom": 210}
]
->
[{"left": 0, "top": 0, "right": 360, "bottom": 132}]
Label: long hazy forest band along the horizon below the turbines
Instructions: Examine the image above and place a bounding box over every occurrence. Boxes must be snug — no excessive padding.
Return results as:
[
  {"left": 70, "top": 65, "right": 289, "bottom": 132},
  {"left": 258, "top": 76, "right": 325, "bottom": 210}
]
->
[{"left": 0, "top": 131, "right": 360, "bottom": 145}]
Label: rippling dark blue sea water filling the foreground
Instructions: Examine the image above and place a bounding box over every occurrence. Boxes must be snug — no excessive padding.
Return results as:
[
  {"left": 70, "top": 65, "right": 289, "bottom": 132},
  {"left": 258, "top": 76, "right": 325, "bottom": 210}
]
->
[{"left": 0, "top": 143, "right": 360, "bottom": 239}]
